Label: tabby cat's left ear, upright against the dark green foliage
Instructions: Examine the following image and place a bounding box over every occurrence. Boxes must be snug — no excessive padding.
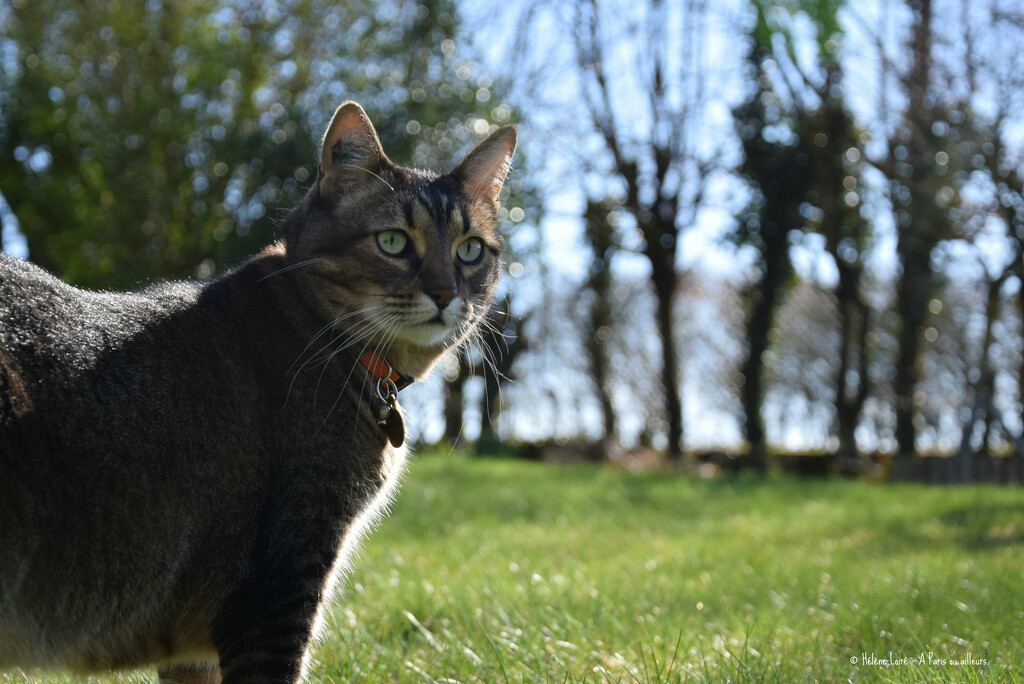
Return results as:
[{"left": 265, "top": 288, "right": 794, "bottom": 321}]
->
[{"left": 317, "top": 101, "right": 390, "bottom": 195}]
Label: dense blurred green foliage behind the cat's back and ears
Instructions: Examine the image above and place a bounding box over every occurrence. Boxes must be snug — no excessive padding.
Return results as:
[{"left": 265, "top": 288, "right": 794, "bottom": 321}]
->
[{"left": 0, "top": 0, "right": 515, "bottom": 288}]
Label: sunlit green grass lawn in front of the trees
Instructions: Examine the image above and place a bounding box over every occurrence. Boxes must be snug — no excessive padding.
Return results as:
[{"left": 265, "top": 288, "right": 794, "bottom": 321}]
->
[{"left": 10, "top": 456, "right": 1024, "bottom": 683}]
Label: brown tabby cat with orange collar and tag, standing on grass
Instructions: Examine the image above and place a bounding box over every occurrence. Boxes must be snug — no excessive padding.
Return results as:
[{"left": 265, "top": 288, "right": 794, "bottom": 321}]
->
[{"left": 0, "top": 102, "right": 517, "bottom": 684}]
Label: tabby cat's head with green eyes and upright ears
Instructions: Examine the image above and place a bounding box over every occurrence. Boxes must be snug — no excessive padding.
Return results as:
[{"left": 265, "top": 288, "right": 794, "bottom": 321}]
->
[{"left": 285, "top": 102, "right": 516, "bottom": 376}]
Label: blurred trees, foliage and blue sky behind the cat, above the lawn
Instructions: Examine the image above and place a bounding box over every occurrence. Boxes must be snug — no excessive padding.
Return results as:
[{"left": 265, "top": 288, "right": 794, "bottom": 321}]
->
[{"left": 0, "top": 0, "right": 1024, "bottom": 481}]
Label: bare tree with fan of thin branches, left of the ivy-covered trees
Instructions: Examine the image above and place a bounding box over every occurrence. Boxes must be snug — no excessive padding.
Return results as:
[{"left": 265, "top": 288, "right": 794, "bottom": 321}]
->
[{"left": 572, "top": 0, "right": 722, "bottom": 461}]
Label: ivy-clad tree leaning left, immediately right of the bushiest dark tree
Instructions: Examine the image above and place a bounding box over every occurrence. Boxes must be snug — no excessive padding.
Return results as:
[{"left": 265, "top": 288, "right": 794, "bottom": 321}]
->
[{"left": 754, "top": 0, "right": 870, "bottom": 468}]
